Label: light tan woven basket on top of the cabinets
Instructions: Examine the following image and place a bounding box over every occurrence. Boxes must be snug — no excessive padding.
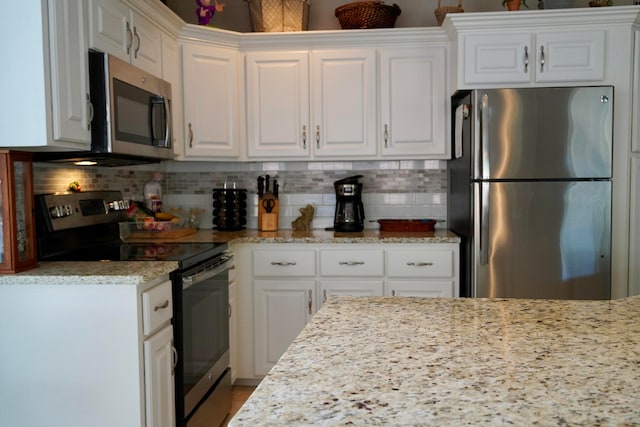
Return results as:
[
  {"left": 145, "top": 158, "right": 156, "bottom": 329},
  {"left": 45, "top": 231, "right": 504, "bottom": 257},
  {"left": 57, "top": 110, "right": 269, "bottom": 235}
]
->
[{"left": 246, "top": 0, "right": 311, "bottom": 32}]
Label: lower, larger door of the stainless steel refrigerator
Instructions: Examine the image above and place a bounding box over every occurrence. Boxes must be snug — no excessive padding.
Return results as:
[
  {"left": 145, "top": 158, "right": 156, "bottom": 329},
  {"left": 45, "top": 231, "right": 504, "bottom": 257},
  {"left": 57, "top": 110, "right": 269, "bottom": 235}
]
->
[{"left": 472, "top": 181, "right": 611, "bottom": 299}]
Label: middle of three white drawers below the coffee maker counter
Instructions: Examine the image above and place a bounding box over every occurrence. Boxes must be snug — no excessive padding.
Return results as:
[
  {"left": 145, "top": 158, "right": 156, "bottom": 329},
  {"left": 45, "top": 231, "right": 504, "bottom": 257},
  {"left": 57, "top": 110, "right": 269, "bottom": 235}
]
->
[{"left": 320, "top": 249, "right": 384, "bottom": 277}]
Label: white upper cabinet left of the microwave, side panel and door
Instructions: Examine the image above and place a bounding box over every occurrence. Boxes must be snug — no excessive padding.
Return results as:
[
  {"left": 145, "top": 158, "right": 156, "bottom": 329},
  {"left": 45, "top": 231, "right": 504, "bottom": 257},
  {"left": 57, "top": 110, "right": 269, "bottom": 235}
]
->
[{"left": 0, "top": 0, "right": 91, "bottom": 150}]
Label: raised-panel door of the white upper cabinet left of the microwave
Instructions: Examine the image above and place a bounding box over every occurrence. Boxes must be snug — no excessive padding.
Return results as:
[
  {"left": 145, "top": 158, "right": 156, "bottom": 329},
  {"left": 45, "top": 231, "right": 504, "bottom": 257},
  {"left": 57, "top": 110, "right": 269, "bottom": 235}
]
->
[{"left": 49, "top": 0, "right": 91, "bottom": 145}]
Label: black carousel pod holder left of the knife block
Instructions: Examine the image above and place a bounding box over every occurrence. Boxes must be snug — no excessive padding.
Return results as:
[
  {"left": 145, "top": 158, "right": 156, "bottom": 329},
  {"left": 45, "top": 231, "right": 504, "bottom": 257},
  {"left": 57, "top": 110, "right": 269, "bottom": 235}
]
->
[{"left": 213, "top": 188, "right": 247, "bottom": 231}]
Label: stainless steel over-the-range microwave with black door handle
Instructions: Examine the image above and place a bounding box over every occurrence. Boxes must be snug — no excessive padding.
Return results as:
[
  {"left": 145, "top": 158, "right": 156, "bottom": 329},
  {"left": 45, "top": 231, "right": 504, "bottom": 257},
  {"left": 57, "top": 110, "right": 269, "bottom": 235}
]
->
[{"left": 36, "top": 52, "right": 174, "bottom": 166}]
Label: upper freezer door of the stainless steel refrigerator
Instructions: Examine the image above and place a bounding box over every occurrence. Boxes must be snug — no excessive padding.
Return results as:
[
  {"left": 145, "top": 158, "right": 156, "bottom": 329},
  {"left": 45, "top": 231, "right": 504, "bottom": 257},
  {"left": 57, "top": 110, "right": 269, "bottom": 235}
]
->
[{"left": 473, "top": 86, "right": 613, "bottom": 180}]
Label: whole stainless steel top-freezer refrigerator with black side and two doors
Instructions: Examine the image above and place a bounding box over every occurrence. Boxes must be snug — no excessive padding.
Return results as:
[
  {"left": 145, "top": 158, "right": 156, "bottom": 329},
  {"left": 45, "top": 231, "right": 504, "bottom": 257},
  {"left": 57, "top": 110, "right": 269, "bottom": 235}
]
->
[{"left": 447, "top": 86, "right": 613, "bottom": 299}]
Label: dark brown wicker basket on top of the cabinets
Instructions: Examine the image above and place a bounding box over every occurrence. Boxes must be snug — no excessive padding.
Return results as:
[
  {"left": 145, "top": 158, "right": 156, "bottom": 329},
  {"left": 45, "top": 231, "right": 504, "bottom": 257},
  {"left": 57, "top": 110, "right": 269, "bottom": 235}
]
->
[{"left": 336, "top": 1, "right": 402, "bottom": 30}]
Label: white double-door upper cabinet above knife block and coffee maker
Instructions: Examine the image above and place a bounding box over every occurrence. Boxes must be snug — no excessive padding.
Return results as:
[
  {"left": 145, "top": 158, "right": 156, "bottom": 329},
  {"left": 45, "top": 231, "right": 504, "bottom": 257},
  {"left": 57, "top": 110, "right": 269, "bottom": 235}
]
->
[{"left": 245, "top": 49, "right": 376, "bottom": 159}]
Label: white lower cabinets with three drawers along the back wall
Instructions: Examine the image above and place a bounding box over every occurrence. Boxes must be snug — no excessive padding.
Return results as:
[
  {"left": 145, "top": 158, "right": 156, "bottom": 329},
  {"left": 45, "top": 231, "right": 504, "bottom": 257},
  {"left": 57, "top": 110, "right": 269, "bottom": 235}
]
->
[{"left": 234, "top": 243, "right": 459, "bottom": 383}]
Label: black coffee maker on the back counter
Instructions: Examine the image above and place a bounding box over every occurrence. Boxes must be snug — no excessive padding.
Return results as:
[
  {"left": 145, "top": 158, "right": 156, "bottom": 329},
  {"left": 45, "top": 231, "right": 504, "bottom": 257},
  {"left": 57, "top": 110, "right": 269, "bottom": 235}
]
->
[{"left": 333, "top": 175, "right": 364, "bottom": 232}]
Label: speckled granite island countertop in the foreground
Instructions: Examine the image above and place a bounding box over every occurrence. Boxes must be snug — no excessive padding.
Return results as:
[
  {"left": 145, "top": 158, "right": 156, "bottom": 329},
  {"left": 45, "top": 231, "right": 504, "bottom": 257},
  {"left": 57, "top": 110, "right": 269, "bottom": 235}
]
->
[{"left": 230, "top": 297, "right": 640, "bottom": 427}]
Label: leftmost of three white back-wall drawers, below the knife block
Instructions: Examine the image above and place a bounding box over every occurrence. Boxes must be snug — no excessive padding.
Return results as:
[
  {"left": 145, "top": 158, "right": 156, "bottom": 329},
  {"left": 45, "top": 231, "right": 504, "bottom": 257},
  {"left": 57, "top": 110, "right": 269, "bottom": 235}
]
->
[{"left": 253, "top": 250, "right": 316, "bottom": 277}]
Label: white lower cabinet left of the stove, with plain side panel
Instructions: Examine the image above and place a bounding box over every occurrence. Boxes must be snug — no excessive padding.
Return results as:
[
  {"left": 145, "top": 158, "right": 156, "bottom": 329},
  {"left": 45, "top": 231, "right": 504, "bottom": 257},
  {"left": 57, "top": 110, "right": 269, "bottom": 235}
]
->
[{"left": 0, "top": 278, "right": 175, "bottom": 427}]
